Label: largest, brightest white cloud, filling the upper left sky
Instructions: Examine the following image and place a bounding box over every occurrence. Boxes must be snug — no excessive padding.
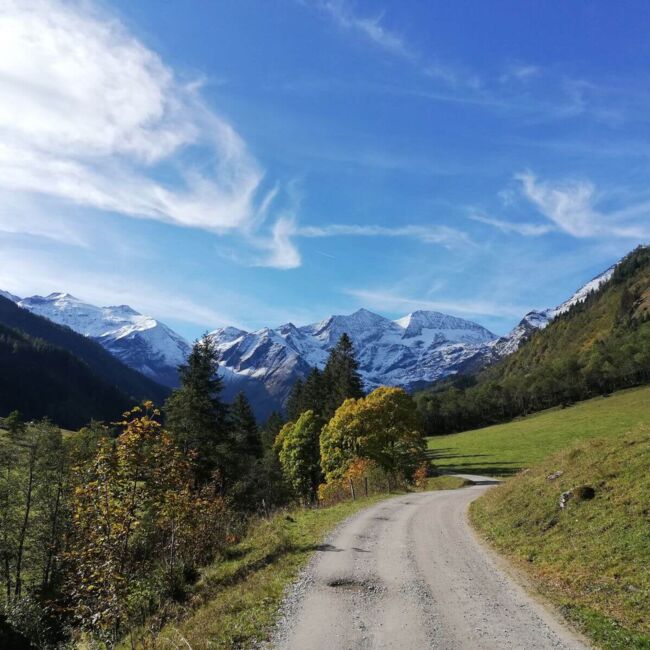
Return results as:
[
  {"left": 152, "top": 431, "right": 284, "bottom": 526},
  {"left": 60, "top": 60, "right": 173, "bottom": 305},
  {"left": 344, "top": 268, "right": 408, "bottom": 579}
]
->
[{"left": 0, "top": 0, "right": 294, "bottom": 266}]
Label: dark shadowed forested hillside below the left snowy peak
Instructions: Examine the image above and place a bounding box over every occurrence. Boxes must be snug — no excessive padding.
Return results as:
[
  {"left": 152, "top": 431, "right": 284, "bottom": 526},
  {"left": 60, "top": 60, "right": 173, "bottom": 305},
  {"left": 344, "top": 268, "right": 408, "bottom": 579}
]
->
[{"left": 0, "top": 296, "right": 167, "bottom": 428}]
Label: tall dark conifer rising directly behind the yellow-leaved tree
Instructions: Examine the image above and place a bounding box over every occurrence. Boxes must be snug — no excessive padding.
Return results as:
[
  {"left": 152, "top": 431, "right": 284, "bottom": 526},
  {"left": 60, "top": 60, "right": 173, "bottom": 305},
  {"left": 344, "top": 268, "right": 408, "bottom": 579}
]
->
[{"left": 321, "top": 333, "right": 364, "bottom": 420}]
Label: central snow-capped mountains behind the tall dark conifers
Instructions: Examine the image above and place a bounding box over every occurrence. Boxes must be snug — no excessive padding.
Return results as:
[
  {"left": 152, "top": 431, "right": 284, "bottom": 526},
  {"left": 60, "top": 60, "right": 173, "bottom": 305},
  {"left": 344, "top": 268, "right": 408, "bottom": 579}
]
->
[{"left": 211, "top": 309, "right": 497, "bottom": 410}]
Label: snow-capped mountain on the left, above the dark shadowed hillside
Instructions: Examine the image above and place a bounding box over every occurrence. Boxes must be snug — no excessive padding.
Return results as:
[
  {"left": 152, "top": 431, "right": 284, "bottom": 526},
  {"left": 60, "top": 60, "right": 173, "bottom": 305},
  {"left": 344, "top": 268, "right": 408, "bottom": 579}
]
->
[{"left": 12, "top": 293, "right": 190, "bottom": 386}]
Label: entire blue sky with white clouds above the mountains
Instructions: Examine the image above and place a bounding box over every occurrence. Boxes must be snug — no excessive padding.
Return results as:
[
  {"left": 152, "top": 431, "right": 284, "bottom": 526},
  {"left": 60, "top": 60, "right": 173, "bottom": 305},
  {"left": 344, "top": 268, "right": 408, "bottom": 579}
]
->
[{"left": 0, "top": 0, "right": 650, "bottom": 339}]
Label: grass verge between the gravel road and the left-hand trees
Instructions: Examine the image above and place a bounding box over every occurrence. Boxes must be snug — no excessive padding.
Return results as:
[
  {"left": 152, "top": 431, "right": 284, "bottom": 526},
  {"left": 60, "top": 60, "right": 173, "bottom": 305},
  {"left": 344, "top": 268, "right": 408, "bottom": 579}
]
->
[{"left": 122, "top": 494, "right": 395, "bottom": 650}]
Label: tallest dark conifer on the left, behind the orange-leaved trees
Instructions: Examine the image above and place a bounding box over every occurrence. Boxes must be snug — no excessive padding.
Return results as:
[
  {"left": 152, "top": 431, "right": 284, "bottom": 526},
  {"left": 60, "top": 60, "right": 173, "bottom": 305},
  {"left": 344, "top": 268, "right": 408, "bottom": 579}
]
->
[{"left": 164, "top": 335, "right": 233, "bottom": 483}]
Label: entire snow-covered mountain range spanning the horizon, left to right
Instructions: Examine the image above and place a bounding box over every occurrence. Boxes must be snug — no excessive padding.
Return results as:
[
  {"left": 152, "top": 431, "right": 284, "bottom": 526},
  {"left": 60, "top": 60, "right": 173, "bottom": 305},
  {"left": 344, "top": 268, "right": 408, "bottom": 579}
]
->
[{"left": 0, "top": 266, "right": 615, "bottom": 418}]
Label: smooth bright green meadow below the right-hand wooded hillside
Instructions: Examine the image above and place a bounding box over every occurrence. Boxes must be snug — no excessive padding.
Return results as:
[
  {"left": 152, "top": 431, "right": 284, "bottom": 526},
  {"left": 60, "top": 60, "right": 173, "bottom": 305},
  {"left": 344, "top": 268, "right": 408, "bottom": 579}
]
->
[{"left": 429, "top": 386, "right": 650, "bottom": 476}]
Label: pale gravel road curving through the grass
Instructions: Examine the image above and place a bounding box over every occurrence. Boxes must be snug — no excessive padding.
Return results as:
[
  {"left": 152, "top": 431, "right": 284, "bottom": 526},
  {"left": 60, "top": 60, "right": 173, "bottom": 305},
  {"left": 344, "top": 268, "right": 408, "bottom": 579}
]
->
[{"left": 272, "top": 476, "right": 590, "bottom": 650}]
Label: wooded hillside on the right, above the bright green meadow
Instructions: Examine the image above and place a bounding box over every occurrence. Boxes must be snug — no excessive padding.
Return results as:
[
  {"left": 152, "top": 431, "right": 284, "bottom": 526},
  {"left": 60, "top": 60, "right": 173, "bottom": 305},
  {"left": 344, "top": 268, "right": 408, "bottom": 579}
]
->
[{"left": 415, "top": 247, "right": 650, "bottom": 435}]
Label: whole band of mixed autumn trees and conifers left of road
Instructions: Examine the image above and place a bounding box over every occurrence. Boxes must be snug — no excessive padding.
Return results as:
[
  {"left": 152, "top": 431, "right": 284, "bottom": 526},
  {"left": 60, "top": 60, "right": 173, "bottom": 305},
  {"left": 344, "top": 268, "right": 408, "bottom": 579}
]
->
[{"left": 0, "top": 336, "right": 426, "bottom": 648}]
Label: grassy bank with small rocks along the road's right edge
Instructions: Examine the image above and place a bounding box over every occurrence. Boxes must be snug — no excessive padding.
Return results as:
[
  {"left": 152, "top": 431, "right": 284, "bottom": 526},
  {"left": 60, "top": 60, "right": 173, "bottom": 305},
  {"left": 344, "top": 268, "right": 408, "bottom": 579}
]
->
[{"left": 470, "top": 426, "right": 650, "bottom": 650}]
